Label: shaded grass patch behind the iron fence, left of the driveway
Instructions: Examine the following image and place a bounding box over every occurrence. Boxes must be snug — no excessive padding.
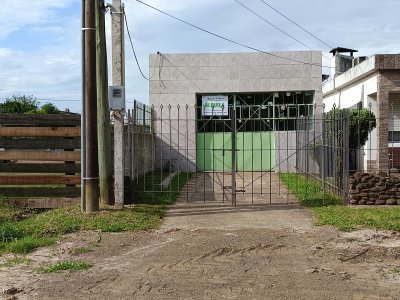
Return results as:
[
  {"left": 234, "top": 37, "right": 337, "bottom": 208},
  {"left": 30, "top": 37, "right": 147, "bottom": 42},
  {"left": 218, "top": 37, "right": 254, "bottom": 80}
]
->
[{"left": 134, "top": 172, "right": 192, "bottom": 205}]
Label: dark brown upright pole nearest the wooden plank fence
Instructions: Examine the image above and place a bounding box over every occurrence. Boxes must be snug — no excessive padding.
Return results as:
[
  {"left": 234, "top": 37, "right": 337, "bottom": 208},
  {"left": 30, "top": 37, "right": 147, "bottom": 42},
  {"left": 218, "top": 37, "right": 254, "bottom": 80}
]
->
[{"left": 83, "top": 0, "right": 99, "bottom": 213}]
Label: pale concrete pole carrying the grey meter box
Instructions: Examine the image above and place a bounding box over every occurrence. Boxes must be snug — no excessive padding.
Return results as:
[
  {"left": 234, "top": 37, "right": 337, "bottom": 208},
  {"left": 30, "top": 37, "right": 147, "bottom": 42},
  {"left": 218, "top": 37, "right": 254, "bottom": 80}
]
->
[{"left": 111, "top": 0, "right": 125, "bottom": 205}]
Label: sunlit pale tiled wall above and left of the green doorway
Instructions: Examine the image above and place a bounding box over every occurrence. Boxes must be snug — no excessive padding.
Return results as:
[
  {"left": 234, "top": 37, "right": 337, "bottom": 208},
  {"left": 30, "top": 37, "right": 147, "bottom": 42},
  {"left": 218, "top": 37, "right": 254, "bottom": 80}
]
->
[{"left": 149, "top": 51, "right": 322, "bottom": 171}]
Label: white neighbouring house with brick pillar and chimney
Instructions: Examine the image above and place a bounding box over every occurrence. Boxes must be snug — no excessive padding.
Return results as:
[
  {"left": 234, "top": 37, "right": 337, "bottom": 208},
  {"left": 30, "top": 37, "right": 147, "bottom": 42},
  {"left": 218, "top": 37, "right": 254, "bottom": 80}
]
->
[{"left": 322, "top": 48, "right": 400, "bottom": 172}]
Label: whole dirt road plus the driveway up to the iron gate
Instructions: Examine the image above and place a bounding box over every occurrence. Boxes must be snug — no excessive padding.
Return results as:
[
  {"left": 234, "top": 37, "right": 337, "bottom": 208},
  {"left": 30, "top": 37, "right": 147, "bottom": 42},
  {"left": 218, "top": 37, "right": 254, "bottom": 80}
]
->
[{"left": 0, "top": 200, "right": 400, "bottom": 300}]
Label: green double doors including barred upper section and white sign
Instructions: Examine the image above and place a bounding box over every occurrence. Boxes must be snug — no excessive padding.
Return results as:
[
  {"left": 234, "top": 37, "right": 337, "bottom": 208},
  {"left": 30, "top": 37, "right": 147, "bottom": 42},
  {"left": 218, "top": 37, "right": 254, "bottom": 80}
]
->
[{"left": 196, "top": 94, "right": 275, "bottom": 172}]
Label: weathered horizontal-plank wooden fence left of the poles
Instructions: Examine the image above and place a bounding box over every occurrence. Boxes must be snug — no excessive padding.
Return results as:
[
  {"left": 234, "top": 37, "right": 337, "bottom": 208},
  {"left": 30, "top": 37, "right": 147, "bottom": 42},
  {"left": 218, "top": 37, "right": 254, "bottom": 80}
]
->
[{"left": 0, "top": 113, "right": 81, "bottom": 208}]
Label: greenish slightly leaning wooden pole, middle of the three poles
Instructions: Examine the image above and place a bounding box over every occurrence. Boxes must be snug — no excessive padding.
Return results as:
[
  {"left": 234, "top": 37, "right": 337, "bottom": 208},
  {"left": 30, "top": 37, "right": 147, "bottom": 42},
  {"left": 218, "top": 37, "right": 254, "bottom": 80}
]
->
[{"left": 96, "top": 0, "right": 114, "bottom": 205}]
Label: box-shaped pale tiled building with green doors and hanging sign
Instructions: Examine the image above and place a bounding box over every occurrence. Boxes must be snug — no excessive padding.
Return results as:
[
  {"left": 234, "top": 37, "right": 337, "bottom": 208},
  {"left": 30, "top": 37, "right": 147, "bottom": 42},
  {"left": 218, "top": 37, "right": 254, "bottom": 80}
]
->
[{"left": 149, "top": 51, "right": 322, "bottom": 171}]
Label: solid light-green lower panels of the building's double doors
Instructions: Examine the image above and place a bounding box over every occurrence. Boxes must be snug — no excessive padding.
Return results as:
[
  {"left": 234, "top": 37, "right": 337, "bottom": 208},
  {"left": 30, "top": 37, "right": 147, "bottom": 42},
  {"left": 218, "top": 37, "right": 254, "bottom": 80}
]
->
[{"left": 196, "top": 131, "right": 275, "bottom": 172}]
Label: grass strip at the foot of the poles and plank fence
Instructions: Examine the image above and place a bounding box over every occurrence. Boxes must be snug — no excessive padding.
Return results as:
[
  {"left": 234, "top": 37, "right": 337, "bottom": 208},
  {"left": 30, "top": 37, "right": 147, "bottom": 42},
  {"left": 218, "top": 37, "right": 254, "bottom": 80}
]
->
[{"left": 0, "top": 205, "right": 165, "bottom": 253}]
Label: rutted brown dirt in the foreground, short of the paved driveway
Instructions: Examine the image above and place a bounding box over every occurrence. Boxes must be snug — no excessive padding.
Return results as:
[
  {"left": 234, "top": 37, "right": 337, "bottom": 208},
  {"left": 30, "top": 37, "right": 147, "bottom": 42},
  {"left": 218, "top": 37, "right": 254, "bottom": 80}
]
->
[{"left": 3, "top": 228, "right": 400, "bottom": 300}]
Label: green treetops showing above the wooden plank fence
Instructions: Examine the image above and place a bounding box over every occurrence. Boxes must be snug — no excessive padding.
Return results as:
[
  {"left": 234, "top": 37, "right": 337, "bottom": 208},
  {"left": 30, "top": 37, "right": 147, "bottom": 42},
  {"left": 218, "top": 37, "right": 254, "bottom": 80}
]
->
[{"left": 0, "top": 95, "right": 60, "bottom": 114}]
